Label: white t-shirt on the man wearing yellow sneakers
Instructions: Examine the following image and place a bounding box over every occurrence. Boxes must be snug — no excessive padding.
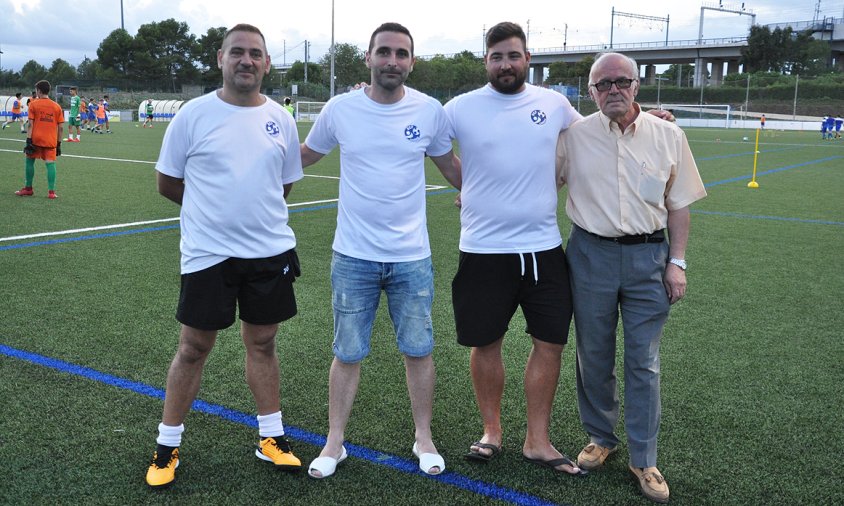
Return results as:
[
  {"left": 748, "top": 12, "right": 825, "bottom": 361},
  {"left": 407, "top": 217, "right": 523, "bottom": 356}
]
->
[{"left": 155, "top": 92, "right": 303, "bottom": 274}]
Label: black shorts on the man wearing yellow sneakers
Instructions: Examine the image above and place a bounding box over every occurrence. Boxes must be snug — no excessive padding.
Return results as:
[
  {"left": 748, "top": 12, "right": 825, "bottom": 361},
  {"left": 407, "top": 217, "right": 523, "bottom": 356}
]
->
[{"left": 176, "top": 249, "right": 300, "bottom": 330}]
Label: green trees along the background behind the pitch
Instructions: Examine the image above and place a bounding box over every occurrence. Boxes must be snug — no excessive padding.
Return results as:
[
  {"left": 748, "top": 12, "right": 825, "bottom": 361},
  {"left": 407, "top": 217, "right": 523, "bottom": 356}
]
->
[{"left": 0, "top": 18, "right": 831, "bottom": 100}]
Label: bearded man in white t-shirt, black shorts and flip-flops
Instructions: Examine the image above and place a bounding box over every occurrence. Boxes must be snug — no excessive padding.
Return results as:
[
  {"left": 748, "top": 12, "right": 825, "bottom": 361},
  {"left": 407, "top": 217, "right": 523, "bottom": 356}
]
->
[{"left": 445, "top": 22, "right": 582, "bottom": 474}]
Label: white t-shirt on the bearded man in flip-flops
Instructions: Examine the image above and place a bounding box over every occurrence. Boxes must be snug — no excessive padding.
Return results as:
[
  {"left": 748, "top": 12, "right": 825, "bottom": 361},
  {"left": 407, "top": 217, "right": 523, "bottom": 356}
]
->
[{"left": 445, "top": 84, "right": 582, "bottom": 253}]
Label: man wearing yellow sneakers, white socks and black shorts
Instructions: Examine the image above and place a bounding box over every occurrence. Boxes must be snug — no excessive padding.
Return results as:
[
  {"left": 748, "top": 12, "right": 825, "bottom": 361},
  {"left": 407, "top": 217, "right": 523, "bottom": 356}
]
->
[{"left": 146, "top": 24, "right": 303, "bottom": 487}]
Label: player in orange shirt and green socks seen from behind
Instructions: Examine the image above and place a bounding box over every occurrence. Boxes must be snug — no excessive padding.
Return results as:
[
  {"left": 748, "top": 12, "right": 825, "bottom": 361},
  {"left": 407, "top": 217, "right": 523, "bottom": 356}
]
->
[{"left": 15, "top": 81, "right": 64, "bottom": 199}]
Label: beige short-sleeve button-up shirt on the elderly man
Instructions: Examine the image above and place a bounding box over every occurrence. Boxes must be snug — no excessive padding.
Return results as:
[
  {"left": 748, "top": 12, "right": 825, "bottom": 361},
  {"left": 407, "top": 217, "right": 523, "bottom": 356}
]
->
[{"left": 557, "top": 105, "right": 706, "bottom": 237}]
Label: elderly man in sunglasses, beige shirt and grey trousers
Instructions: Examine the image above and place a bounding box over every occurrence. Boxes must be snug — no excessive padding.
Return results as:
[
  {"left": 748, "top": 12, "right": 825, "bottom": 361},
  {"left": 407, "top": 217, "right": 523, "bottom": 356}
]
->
[{"left": 557, "top": 53, "right": 706, "bottom": 502}]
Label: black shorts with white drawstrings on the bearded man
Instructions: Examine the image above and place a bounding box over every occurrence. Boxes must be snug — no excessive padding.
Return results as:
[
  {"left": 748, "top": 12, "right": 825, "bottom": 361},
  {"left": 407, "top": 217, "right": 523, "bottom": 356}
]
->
[{"left": 451, "top": 246, "right": 572, "bottom": 346}]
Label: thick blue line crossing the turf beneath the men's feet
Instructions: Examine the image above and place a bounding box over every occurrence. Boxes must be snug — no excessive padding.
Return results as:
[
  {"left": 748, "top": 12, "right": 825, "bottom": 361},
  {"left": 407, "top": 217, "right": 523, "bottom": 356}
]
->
[{"left": 0, "top": 344, "right": 559, "bottom": 506}]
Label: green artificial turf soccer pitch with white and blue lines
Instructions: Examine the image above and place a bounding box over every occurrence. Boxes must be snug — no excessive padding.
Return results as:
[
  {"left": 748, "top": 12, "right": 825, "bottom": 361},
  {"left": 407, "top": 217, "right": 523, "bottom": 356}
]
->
[{"left": 0, "top": 123, "right": 844, "bottom": 505}]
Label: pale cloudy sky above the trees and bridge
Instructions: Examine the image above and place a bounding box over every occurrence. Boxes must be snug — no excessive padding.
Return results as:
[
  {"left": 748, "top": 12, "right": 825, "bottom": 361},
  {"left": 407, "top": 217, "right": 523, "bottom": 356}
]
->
[{"left": 0, "top": 0, "right": 844, "bottom": 71}]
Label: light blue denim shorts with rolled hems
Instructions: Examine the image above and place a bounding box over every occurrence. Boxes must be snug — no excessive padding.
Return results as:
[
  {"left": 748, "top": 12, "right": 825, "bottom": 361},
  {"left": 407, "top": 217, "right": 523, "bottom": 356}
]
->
[{"left": 331, "top": 251, "right": 434, "bottom": 364}]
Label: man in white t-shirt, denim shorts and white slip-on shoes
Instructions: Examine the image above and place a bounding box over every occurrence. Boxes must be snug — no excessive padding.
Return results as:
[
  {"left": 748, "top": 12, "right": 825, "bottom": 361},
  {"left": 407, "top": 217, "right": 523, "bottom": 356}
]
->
[{"left": 302, "top": 23, "right": 460, "bottom": 478}]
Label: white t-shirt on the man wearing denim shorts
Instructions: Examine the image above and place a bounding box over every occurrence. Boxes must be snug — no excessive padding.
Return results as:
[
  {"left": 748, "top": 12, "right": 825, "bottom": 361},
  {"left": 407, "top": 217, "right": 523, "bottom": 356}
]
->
[{"left": 305, "top": 87, "right": 451, "bottom": 262}]
